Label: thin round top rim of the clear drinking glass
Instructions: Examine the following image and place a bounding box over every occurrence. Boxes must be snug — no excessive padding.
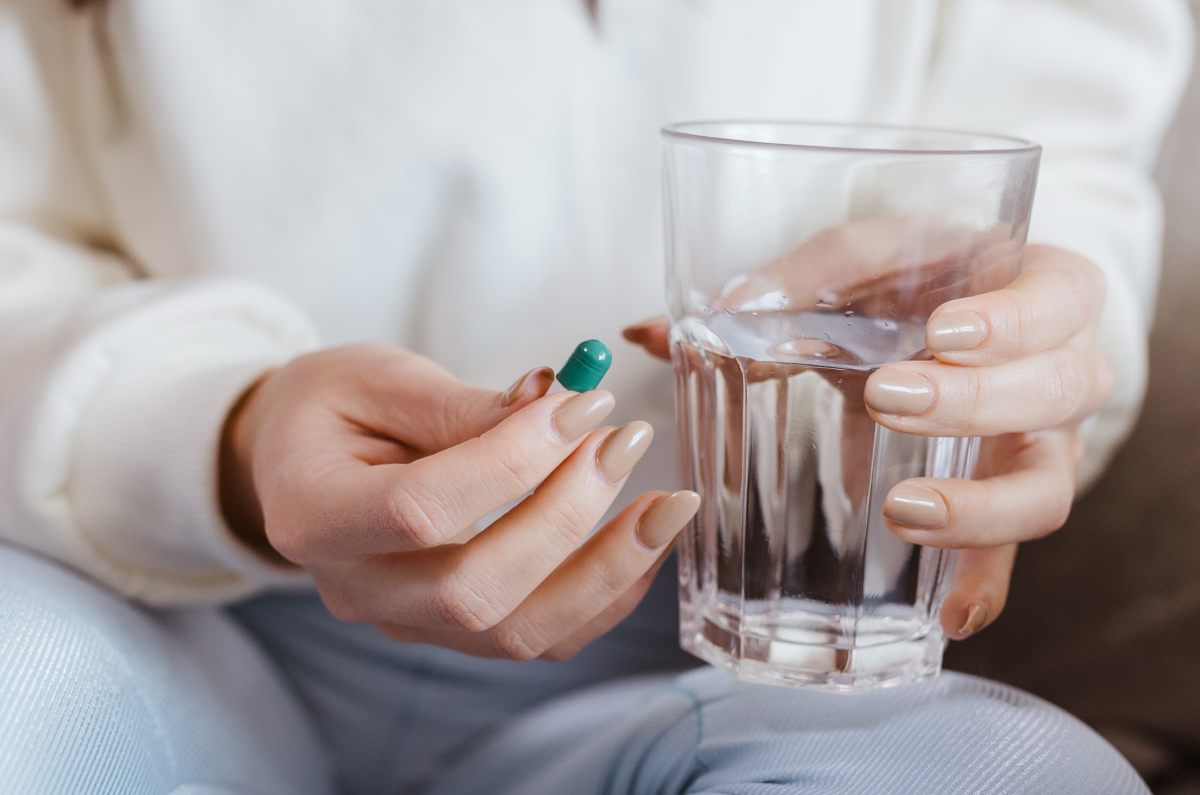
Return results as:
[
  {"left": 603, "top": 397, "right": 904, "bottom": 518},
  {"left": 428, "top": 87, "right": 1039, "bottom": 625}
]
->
[{"left": 659, "top": 119, "right": 1042, "bottom": 157}]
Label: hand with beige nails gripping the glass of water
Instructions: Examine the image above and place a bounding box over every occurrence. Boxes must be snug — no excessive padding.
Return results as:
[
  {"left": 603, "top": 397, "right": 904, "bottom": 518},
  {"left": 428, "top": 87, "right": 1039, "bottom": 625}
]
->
[{"left": 625, "top": 246, "right": 1112, "bottom": 640}]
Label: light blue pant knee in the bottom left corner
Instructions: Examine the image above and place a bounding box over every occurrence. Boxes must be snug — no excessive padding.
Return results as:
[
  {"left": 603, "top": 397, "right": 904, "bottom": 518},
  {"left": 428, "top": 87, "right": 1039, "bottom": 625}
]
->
[{"left": 0, "top": 545, "right": 331, "bottom": 795}]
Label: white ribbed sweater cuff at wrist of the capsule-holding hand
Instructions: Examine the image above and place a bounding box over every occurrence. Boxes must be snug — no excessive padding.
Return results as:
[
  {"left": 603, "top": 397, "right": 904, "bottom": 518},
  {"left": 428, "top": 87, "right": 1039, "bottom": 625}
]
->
[{"left": 67, "top": 283, "right": 314, "bottom": 605}]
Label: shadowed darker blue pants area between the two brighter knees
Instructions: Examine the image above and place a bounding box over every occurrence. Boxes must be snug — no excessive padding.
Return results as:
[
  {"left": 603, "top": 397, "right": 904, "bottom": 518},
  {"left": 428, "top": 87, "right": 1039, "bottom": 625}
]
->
[{"left": 230, "top": 569, "right": 698, "bottom": 795}]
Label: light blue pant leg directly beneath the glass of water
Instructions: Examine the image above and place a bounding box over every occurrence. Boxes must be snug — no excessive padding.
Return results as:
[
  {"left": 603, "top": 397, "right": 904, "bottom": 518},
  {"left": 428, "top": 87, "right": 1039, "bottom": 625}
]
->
[{"left": 427, "top": 669, "right": 1148, "bottom": 795}]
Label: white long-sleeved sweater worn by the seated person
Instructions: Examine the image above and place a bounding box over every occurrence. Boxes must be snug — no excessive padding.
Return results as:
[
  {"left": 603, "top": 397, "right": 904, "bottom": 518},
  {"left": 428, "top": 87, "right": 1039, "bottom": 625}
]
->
[{"left": 0, "top": 0, "right": 1190, "bottom": 604}]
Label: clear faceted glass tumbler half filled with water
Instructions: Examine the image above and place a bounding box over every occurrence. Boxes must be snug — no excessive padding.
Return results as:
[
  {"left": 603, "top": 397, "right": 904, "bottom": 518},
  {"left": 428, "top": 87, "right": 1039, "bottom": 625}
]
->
[{"left": 664, "top": 121, "right": 1040, "bottom": 692}]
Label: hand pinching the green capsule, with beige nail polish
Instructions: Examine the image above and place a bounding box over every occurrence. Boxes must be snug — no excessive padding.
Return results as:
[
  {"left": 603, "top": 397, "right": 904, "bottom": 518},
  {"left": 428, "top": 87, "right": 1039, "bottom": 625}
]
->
[{"left": 221, "top": 346, "right": 700, "bottom": 659}]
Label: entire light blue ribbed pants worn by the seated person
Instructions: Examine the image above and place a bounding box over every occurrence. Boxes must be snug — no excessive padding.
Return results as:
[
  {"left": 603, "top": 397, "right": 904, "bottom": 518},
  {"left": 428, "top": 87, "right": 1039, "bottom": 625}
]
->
[{"left": 0, "top": 546, "right": 1147, "bottom": 795}]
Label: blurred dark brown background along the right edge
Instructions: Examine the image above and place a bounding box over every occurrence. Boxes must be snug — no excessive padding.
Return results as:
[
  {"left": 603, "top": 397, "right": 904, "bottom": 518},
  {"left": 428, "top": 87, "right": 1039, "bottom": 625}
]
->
[{"left": 948, "top": 0, "right": 1200, "bottom": 795}]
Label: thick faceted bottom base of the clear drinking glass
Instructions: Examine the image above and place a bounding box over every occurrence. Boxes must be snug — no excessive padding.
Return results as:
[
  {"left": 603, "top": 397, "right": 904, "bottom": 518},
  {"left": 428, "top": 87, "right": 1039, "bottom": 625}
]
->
[{"left": 679, "top": 605, "right": 944, "bottom": 693}]
